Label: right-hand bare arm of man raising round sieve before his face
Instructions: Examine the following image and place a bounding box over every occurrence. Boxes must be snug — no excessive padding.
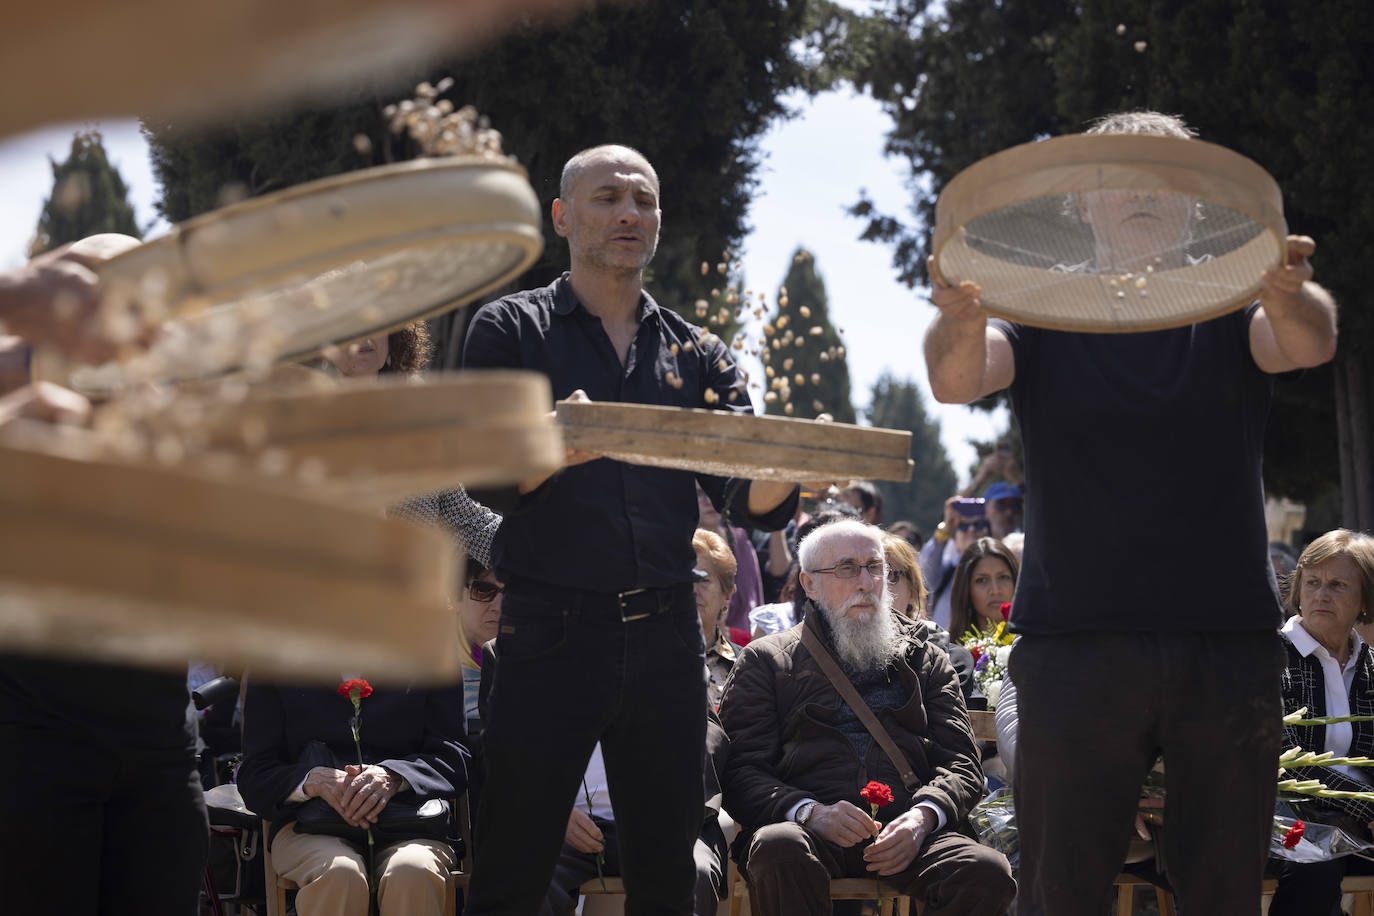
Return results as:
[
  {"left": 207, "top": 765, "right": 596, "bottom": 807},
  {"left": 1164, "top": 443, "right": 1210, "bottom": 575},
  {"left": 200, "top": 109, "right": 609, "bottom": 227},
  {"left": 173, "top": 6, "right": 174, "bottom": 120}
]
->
[{"left": 1250, "top": 235, "right": 1336, "bottom": 374}]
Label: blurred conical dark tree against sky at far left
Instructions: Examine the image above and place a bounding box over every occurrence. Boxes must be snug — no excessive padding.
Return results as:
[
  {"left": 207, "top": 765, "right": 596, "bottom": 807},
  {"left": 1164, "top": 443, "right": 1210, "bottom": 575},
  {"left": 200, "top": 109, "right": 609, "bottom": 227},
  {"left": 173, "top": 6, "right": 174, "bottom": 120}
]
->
[{"left": 29, "top": 130, "right": 143, "bottom": 257}]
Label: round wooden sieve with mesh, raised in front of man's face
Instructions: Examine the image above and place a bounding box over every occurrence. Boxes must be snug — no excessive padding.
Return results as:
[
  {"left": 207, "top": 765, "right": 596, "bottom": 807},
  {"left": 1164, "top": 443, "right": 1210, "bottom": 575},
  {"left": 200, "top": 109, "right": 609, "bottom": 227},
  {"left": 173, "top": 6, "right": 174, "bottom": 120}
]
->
[{"left": 934, "top": 135, "right": 1286, "bottom": 331}]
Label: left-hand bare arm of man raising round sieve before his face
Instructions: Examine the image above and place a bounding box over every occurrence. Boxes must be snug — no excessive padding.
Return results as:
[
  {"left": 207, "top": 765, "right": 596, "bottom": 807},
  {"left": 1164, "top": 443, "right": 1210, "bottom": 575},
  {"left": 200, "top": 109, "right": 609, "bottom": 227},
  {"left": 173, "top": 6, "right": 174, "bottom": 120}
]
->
[{"left": 925, "top": 256, "right": 1015, "bottom": 404}]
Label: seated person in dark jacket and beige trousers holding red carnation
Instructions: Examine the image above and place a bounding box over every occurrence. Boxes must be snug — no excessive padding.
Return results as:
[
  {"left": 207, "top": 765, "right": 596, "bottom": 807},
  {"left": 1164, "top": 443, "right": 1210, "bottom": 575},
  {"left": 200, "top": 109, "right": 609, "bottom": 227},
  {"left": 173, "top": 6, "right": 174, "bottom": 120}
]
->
[{"left": 238, "top": 684, "right": 467, "bottom": 916}]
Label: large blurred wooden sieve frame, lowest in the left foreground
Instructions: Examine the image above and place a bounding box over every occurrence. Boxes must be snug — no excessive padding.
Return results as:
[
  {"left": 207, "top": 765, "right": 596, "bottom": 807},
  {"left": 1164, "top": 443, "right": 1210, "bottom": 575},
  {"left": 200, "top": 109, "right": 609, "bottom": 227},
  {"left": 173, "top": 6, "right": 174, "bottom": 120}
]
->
[{"left": 0, "top": 446, "right": 459, "bottom": 684}]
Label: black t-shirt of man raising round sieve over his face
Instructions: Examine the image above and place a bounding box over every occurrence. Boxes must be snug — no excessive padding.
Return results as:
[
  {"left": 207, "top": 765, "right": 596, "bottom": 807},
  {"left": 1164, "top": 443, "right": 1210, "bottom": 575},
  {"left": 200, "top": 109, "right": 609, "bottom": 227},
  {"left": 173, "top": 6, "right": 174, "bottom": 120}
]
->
[{"left": 993, "top": 305, "right": 1282, "bottom": 634}]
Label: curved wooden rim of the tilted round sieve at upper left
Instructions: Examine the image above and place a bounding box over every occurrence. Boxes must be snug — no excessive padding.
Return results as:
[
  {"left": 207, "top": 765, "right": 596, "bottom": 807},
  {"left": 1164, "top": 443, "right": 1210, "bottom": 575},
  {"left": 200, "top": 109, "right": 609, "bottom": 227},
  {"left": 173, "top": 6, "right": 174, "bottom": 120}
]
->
[{"left": 37, "top": 157, "right": 544, "bottom": 393}]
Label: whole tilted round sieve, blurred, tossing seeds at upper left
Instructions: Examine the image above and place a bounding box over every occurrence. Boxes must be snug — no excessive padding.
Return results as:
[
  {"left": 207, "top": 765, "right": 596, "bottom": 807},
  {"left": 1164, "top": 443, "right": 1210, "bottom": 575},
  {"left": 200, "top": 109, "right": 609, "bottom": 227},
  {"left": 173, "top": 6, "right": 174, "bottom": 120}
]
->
[{"left": 48, "top": 157, "right": 543, "bottom": 393}]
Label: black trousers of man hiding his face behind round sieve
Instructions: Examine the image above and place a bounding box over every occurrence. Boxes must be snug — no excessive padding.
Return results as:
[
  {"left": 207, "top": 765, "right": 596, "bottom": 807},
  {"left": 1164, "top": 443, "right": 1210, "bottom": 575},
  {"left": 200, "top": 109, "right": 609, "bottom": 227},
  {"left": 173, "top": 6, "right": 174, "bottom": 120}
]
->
[{"left": 1010, "top": 632, "right": 1283, "bottom": 916}]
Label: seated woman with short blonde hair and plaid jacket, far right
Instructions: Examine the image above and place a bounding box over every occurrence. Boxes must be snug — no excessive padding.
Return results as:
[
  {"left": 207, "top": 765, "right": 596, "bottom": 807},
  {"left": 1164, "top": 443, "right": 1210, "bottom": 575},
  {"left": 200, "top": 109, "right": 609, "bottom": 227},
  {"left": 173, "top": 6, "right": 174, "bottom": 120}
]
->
[{"left": 1270, "top": 529, "right": 1374, "bottom": 916}]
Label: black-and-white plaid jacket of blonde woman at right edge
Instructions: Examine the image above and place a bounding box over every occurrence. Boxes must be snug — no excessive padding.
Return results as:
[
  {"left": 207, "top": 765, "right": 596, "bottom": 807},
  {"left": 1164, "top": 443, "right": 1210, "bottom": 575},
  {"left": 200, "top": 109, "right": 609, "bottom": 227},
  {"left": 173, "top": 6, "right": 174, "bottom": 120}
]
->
[{"left": 1282, "top": 636, "right": 1374, "bottom": 824}]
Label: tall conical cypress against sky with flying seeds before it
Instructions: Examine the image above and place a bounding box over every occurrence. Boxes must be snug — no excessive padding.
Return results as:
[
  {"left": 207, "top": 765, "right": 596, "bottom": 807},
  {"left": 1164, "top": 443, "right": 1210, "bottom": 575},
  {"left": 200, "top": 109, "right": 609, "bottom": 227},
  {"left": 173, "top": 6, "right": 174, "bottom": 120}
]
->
[{"left": 760, "top": 249, "right": 856, "bottom": 423}]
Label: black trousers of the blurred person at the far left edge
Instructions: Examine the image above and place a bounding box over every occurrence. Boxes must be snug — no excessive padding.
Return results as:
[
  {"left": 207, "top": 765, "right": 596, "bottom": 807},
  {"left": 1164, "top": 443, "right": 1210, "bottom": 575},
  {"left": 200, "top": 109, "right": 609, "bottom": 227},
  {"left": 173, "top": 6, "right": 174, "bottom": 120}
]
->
[{"left": 0, "top": 724, "right": 209, "bottom": 916}]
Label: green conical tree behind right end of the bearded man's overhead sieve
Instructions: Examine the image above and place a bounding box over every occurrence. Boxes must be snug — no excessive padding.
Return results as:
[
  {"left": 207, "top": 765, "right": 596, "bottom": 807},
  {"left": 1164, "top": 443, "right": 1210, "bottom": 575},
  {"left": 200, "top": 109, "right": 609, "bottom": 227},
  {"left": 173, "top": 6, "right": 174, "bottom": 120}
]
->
[{"left": 867, "top": 375, "right": 959, "bottom": 537}]
